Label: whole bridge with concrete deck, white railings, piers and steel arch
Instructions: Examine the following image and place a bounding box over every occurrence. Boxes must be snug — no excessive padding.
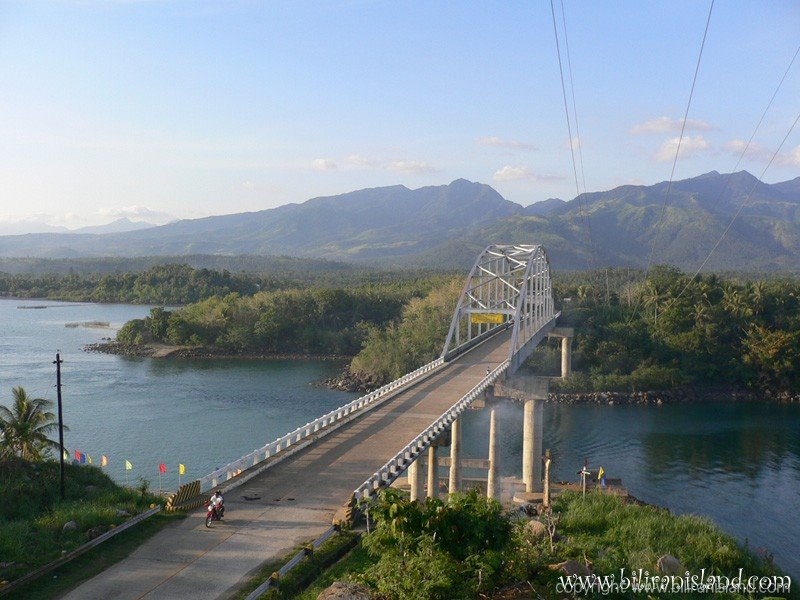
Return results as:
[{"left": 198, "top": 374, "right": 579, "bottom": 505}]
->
[{"left": 66, "top": 245, "right": 569, "bottom": 600}]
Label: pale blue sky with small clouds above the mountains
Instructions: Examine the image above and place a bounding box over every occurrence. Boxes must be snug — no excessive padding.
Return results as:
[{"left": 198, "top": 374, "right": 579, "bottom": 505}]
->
[{"left": 0, "top": 0, "right": 800, "bottom": 233}]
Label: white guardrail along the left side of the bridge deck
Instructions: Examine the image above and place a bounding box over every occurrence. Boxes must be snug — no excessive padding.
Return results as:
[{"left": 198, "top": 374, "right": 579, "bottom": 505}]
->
[{"left": 195, "top": 358, "right": 444, "bottom": 492}]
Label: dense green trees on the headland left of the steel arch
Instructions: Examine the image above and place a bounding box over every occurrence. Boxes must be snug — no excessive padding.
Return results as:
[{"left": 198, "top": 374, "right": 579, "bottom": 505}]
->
[{"left": 117, "top": 279, "right": 450, "bottom": 356}]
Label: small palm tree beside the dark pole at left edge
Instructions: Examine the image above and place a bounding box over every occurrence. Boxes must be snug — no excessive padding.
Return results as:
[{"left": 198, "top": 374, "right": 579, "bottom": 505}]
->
[{"left": 0, "top": 387, "right": 66, "bottom": 460}]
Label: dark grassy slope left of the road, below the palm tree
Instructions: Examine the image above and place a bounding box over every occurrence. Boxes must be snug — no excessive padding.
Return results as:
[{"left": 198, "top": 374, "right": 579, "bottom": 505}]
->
[{"left": 0, "top": 459, "right": 179, "bottom": 598}]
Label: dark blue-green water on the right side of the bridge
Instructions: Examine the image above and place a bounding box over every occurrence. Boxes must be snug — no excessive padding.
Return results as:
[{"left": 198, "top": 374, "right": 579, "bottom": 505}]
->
[{"left": 464, "top": 401, "right": 800, "bottom": 577}]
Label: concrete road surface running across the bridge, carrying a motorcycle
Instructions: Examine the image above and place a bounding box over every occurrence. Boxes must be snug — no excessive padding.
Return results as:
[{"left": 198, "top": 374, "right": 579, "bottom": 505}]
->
[{"left": 66, "top": 331, "right": 510, "bottom": 600}]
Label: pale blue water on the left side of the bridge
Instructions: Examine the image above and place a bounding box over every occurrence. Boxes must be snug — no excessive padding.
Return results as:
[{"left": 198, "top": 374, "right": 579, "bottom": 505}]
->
[{"left": 0, "top": 298, "right": 356, "bottom": 489}]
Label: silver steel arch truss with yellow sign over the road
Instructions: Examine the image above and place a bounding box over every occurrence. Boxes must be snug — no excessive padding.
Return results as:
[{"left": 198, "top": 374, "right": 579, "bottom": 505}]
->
[{"left": 442, "top": 244, "right": 561, "bottom": 374}]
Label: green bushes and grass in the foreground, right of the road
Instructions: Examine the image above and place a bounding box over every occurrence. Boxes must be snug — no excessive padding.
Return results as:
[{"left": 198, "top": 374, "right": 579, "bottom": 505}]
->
[{"left": 274, "top": 489, "right": 792, "bottom": 600}]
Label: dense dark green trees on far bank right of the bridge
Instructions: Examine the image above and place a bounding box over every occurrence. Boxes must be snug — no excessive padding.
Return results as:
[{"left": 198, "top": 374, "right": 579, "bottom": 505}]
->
[{"left": 558, "top": 267, "right": 800, "bottom": 391}]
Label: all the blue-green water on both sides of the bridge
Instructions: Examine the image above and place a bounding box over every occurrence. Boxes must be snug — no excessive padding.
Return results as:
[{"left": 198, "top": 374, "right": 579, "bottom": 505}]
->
[{"left": 0, "top": 299, "right": 800, "bottom": 577}]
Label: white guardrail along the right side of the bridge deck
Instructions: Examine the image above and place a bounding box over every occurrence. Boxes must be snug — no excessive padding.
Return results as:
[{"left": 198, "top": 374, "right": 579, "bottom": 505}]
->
[{"left": 353, "top": 360, "right": 509, "bottom": 501}]
